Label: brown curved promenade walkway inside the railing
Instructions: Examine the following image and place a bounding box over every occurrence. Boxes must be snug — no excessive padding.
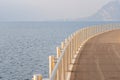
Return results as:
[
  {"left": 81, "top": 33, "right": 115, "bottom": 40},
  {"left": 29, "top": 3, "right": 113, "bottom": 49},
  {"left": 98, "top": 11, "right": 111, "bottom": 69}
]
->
[{"left": 71, "top": 30, "right": 120, "bottom": 80}]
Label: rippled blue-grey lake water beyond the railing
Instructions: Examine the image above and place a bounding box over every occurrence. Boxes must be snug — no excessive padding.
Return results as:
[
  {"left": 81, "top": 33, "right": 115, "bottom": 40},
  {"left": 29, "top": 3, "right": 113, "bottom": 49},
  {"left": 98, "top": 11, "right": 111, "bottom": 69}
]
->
[{"left": 0, "top": 22, "right": 119, "bottom": 80}]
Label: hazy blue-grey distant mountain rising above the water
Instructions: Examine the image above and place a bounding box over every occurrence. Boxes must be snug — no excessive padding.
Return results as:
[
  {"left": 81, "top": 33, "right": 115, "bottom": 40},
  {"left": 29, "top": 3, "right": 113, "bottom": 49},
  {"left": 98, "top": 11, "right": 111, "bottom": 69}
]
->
[{"left": 78, "top": 0, "right": 120, "bottom": 21}]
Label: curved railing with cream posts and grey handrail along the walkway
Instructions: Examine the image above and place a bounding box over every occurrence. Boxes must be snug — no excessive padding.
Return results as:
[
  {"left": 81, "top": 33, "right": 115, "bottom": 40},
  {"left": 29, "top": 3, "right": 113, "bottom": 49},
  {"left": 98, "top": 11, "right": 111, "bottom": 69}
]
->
[{"left": 32, "top": 23, "right": 120, "bottom": 80}]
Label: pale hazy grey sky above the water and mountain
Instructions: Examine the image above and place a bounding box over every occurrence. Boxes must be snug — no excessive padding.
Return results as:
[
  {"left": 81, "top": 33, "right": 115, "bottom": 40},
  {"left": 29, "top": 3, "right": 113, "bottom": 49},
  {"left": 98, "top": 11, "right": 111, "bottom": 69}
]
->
[{"left": 0, "top": 0, "right": 113, "bottom": 21}]
